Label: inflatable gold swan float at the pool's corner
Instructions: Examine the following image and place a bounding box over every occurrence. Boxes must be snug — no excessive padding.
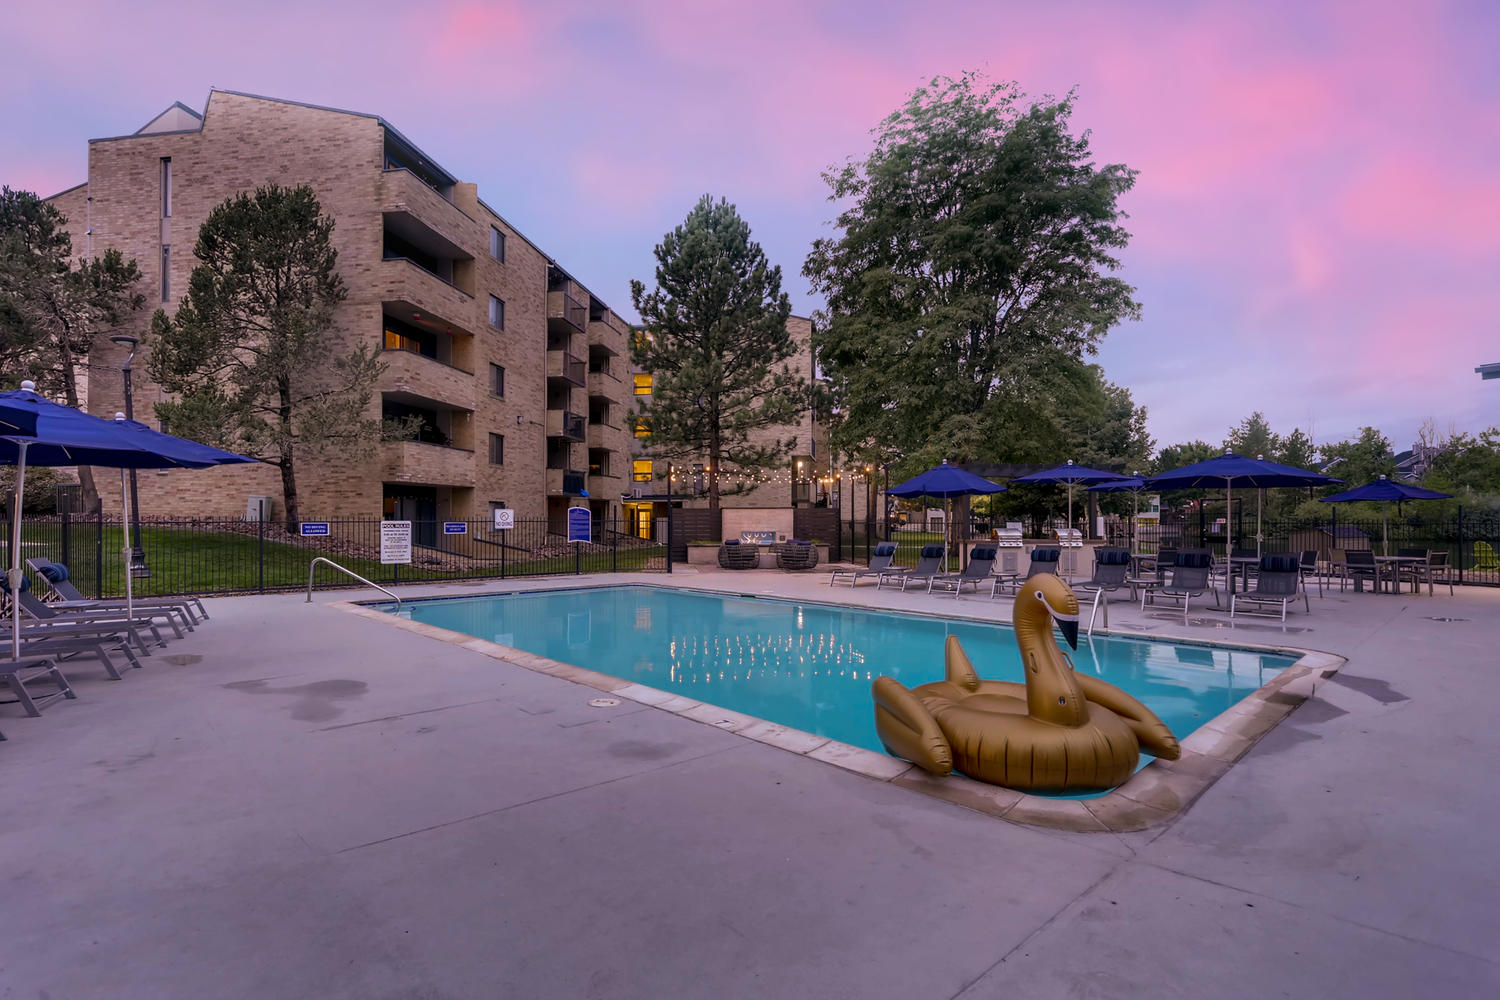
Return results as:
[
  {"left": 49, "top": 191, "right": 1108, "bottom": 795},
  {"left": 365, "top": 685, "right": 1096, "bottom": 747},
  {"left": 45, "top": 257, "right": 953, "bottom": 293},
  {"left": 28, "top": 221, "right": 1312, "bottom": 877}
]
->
[{"left": 873, "top": 573, "right": 1182, "bottom": 792}]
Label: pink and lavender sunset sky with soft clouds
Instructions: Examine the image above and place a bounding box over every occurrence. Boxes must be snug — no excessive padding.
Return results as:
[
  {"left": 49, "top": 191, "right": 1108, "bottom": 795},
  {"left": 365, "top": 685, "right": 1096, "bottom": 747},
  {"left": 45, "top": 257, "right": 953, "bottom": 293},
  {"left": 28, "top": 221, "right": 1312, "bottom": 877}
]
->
[{"left": 0, "top": 0, "right": 1500, "bottom": 450}]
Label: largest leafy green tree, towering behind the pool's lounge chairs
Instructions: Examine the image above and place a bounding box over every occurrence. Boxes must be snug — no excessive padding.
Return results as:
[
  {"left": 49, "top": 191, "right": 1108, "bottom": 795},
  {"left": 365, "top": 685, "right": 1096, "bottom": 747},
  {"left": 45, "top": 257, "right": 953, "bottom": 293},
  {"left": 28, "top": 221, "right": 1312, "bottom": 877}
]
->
[{"left": 803, "top": 73, "right": 1140, "bottom": 462}]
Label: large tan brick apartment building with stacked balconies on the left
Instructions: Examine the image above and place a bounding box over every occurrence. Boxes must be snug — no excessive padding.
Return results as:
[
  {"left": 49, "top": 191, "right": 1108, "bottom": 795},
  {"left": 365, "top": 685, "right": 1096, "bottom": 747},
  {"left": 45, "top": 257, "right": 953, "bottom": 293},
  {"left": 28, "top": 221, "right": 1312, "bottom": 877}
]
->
[{"left": 51, "top": 90, "right": 633, "bottom": 543}]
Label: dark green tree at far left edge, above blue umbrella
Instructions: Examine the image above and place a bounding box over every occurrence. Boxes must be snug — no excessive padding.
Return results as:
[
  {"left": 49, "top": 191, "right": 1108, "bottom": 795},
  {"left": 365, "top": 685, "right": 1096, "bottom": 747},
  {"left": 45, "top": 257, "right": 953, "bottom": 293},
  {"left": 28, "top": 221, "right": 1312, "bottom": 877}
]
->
[{"left": 0, "top": 187, "right": 146, "bottom": 510}]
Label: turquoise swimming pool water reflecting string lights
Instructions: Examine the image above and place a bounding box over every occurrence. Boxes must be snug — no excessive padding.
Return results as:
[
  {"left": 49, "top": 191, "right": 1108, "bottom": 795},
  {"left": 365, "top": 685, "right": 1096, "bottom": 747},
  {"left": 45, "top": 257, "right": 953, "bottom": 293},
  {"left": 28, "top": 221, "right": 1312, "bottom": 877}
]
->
[{"left": 380, "top": 586, "right": 1295, "bottom": 753}]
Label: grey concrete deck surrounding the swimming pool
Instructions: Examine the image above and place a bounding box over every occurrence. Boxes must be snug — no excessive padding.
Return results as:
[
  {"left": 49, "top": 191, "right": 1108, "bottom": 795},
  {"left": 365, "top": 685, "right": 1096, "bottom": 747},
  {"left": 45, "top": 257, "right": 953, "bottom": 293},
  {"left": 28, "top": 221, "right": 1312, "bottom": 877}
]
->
[{"left": 0, "top": 573, "right": 1500, "bottom": 1000}]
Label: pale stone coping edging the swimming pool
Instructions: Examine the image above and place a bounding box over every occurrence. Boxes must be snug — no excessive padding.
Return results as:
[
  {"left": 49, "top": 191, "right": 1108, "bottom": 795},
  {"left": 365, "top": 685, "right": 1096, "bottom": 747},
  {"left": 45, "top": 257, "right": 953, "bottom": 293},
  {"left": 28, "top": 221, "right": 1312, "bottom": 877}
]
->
[{"left": 327, "top": 582, "right": 1347, "bottom": 834}]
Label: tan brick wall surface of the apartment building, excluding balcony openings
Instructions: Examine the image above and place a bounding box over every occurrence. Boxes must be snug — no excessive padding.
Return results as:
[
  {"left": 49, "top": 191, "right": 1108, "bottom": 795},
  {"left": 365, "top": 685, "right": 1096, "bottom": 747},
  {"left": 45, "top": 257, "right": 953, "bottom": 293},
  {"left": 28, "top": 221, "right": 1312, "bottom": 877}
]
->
[{"left": 45, "top": 91, "right": 629, "bottom": 527}]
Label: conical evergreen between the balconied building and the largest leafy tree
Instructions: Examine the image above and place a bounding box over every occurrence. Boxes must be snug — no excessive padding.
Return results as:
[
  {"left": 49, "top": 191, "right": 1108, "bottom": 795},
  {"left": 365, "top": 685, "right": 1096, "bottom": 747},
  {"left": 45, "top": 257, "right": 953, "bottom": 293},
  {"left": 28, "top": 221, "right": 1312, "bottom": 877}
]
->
[{"left": 630, "top": 195, "right": 810, "bottom": 510}]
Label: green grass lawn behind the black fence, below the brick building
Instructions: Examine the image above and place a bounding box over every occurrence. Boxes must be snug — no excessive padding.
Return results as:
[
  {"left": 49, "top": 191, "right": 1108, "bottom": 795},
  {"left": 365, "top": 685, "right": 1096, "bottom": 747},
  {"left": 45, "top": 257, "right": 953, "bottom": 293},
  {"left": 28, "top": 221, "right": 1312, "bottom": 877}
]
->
[{"left": 23, "top": 523, "right": 665, "bottom": 597}]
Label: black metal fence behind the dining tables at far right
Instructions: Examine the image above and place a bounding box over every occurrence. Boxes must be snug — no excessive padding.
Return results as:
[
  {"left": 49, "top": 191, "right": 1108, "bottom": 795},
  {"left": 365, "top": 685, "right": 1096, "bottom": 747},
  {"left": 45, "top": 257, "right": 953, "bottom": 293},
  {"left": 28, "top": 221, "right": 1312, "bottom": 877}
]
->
[{"left": 1110, "top": 508, "right": 1500, "bottom": 586}]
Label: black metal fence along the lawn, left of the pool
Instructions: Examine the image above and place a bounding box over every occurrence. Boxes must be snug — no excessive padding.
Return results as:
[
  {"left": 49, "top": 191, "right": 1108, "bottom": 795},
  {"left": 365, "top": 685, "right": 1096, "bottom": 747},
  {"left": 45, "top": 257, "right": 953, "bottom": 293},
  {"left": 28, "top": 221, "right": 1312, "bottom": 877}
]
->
[{"left": 3, "top": 516, "right": 668, "bottom": 597}]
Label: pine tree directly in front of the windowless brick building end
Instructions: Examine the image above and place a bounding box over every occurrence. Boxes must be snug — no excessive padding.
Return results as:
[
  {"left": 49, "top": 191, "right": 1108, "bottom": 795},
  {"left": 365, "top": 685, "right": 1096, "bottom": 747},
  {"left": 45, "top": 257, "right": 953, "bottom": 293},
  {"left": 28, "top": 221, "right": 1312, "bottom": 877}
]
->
[{"left": 150, "top": 184, "right": 384, "bottom": 531}]
